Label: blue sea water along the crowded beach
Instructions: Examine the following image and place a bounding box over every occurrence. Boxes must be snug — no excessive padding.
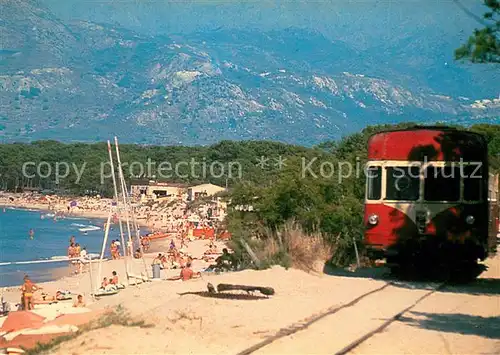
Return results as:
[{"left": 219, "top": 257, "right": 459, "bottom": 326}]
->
[{"left": 0, "top": 207, "right": 120, "bottom": 287}]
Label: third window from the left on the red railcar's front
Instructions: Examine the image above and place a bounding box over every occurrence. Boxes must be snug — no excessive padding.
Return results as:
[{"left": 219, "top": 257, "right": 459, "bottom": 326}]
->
[{"left": 424, "top": 166, "right": 460, "bottom": 201}]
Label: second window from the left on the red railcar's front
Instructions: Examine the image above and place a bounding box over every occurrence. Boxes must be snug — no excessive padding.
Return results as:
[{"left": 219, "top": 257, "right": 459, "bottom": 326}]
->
[{"left": 385, "top": 166, "right": 420, "bottom": 201}]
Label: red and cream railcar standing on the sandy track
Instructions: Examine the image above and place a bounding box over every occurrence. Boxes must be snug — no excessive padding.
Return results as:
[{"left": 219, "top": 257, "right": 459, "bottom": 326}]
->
[{"left": 364, "top": 127, "right": 498, "bottom": 264}]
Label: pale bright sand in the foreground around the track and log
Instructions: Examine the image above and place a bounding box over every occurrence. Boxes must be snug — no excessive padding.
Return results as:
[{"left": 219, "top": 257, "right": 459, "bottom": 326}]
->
[{"left": 1, "top": 234, "right": 500, "bottom": 355}]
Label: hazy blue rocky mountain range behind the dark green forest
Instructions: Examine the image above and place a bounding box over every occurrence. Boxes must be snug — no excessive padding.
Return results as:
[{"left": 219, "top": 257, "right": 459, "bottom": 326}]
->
[{"left": 0, "top": 0, "right": 500, "bottom": 145}]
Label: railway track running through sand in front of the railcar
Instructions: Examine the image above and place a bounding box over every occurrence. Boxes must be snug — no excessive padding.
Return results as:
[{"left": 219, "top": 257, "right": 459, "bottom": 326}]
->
[{"left": 238, "top": 282, "right": 446, "bottom": 355}]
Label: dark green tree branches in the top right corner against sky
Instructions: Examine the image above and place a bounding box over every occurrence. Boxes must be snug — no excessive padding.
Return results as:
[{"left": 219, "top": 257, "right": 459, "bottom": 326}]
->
[{"left": 455, "top": 0, "right": 500, "bottom": 63}]
